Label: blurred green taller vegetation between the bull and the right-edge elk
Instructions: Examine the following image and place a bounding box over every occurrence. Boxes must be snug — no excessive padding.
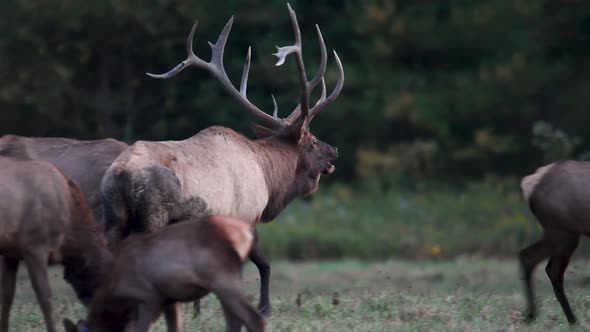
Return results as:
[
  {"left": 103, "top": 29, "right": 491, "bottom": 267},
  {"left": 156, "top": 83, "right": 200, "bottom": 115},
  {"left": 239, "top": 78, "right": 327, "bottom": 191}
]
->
[{"left": 258, "top": 178, "right": 541, "bottom": 260}]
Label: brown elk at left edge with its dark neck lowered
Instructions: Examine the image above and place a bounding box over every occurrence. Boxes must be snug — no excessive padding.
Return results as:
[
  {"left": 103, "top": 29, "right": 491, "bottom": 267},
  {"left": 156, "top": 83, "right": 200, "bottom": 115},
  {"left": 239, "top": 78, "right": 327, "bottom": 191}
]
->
[{"left": 0, "top": 157, "right": 111, "bottom": 332}]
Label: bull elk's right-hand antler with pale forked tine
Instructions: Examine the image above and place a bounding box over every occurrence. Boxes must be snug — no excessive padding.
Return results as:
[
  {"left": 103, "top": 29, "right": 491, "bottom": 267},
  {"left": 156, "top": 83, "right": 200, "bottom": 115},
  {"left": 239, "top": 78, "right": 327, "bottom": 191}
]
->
[{"left": 273, "top": 3, "right": 344, "bottom": 126}]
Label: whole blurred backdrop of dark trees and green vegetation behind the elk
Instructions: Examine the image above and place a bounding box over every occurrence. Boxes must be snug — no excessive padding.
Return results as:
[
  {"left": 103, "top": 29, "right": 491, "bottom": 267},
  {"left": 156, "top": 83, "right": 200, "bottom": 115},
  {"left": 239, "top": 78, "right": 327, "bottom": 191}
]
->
[{"left": 0, "top": 0, "right": 590, "bottom": 259}]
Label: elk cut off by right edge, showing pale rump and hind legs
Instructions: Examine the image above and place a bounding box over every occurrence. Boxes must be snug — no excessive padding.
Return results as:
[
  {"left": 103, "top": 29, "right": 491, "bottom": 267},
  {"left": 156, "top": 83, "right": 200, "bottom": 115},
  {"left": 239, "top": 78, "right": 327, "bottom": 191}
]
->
[{"left": 520, "top": 160, "right": 590, "bottom": 324}]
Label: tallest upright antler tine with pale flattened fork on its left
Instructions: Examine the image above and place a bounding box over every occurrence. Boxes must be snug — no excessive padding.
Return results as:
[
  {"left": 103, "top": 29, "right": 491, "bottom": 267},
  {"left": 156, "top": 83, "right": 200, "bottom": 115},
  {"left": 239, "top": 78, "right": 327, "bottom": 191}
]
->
[{"left": 273, "top": 3, "right": 310, "bottom": 123}]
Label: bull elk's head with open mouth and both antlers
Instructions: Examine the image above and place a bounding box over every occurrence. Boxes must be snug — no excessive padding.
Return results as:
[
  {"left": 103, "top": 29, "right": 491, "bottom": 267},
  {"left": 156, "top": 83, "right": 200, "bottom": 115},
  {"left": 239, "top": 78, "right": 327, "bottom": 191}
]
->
[{"left": 147, "top": 4, "right": 344, "bottom": 195}]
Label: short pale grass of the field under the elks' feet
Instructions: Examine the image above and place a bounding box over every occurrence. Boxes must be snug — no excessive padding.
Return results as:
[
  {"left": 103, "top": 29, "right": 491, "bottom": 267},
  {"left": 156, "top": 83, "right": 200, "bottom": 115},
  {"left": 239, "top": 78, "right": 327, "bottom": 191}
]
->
[{"left": 11, "top": 257, "right": 590, "bottom": 332}]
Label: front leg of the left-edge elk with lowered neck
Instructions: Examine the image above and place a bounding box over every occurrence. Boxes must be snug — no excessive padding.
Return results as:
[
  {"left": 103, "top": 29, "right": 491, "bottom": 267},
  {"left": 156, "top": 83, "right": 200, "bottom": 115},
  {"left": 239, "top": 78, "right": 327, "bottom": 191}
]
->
[{"left": 24, "top": 250, "right": 56, "bottom": 332}]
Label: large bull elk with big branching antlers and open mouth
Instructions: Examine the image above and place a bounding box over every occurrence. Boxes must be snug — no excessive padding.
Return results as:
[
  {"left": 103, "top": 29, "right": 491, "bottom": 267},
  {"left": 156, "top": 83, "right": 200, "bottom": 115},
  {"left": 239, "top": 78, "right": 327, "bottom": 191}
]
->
[{"left": 102, "top": 6, "right": 344, "bottom": 314}]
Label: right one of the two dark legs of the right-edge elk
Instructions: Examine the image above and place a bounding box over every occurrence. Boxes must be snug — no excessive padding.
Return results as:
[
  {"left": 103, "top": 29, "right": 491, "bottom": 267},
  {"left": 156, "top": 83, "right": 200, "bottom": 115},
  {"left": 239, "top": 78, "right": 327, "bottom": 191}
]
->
[{"left": 545, "top": 233, "right": 580, "bottom": 324}]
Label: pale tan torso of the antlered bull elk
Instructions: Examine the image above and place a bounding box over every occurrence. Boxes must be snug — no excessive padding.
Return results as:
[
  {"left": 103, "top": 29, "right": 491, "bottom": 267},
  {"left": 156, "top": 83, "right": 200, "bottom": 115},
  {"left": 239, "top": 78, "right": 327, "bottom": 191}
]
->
[{"left": 105, "top": 127, "right": 272, "bottom": 227}]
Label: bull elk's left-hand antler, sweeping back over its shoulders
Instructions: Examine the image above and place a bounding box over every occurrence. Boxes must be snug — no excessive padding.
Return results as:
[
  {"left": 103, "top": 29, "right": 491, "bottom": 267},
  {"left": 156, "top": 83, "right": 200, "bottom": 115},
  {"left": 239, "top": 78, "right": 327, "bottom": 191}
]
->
[{"left": 147, "top": 16, "right": 285, "bottom": 128}]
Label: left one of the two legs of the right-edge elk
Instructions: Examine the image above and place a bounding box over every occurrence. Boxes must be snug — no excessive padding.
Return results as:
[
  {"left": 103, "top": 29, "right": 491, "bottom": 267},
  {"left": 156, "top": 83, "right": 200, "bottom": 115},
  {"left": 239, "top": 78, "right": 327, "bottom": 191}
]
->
[{"left": 519, "top": 236, "right": 551, "bottom": 322}]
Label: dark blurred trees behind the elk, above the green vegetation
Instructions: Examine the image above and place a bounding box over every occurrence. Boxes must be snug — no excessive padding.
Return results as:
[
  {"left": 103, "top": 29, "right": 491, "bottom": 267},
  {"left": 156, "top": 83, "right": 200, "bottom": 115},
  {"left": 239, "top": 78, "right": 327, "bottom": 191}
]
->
[{"left": 0, "top": 0, "right": 590, "bottom": 179}]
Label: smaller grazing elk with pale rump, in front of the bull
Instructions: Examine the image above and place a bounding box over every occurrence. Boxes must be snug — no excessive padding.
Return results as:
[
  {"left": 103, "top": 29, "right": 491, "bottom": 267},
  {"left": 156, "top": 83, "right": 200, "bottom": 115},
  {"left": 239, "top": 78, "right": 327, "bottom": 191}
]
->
[{"left": 64, "top": 216, "right": 264, "bottom": 332}]
